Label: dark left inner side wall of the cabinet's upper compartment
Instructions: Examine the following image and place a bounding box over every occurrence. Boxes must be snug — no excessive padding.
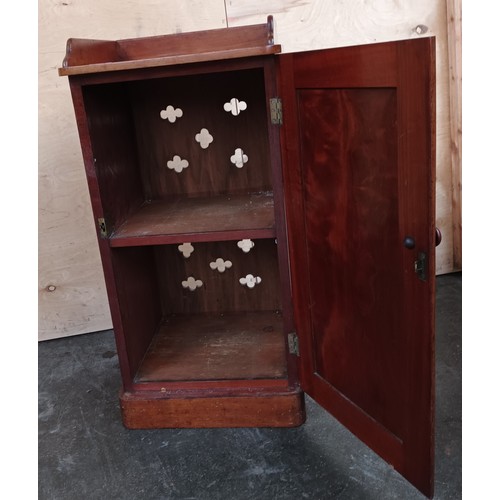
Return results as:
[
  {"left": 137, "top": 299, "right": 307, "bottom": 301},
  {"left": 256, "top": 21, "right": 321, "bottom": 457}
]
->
[{"left": 83, "top": 85, "right": 144, "bottom": 231}]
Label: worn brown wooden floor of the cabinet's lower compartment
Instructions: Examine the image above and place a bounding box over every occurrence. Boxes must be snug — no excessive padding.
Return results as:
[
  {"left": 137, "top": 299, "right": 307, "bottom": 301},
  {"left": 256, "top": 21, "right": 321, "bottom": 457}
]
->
[{"left": 135, "top": 311, "right": 287, "bottom": 383}]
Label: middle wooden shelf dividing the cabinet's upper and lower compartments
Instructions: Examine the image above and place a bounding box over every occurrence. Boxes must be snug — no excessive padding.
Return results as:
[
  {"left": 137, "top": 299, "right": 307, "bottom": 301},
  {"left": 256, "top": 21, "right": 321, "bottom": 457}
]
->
[{"left": 110, "top": 192, "right": 275, "bottom": 247}]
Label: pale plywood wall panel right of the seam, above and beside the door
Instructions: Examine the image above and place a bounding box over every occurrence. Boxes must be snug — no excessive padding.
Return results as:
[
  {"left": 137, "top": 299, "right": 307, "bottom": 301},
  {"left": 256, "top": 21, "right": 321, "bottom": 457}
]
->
[{"left": 227, "top": 0, "right": 454, "bottom": 274}]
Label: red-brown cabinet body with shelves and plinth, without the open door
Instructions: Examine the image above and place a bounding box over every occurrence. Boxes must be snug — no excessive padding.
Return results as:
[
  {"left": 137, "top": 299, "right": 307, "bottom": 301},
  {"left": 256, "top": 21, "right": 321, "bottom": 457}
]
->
[{"left": 64, "top": 20, "right": 304, "bottom": 428}]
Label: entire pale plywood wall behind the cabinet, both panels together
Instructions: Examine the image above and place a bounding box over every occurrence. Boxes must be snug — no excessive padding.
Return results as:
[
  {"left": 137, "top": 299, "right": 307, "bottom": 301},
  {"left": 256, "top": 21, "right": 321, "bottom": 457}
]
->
[{"left": 38, "top": 0, "right": 457, "bottom": 340}]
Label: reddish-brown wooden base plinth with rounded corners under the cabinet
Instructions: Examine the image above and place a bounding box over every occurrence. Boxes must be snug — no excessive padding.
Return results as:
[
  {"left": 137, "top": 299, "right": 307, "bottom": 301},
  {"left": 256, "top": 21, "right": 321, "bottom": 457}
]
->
[{"left": 120, "top": 390, "right": 305, "bottom": 429}]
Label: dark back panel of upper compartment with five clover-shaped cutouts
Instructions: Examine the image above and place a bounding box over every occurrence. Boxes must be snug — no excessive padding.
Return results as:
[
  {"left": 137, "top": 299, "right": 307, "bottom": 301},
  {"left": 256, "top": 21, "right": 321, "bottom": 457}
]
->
[{"left": 129, "top": 69, "right": 271, "bottom": 199}]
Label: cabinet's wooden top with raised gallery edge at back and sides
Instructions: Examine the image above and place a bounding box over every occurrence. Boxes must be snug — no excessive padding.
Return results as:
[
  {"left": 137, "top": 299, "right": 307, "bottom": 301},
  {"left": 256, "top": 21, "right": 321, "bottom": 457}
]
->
[{"left": 59, "top": 16, "right": 281, "bottom": 76}]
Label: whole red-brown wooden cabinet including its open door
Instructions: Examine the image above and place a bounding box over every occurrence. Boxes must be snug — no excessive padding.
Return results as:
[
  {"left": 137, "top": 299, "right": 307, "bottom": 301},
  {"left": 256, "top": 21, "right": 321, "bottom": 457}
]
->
[{"left": 59, "top": 18, "right": 435, "bottom": 495}]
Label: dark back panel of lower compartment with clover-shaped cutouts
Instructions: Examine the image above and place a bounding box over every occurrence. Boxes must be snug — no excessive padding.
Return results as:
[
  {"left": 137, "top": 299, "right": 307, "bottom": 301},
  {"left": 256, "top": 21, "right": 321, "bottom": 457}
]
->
[{"left": 156, "top": 239, "right": 281, "bottom": 314}]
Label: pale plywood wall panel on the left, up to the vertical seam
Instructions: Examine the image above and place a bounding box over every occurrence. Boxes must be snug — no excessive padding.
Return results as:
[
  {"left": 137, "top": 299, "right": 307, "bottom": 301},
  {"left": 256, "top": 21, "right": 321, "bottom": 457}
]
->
[{"left": 38, "top": 0, "right": 226, "bottom": 340}]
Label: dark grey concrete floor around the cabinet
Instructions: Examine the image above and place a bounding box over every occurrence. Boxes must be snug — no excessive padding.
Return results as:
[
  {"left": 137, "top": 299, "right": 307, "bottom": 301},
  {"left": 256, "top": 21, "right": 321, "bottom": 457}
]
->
[{"left": 38, "top": 274, "right": 462, "bottom": 500}]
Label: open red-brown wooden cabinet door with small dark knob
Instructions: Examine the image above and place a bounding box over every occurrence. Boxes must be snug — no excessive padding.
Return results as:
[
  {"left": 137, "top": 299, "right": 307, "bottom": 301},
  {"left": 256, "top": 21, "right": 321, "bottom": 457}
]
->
[{"left": 279, "top": 38, "right": 435, "bottom": 497}]
